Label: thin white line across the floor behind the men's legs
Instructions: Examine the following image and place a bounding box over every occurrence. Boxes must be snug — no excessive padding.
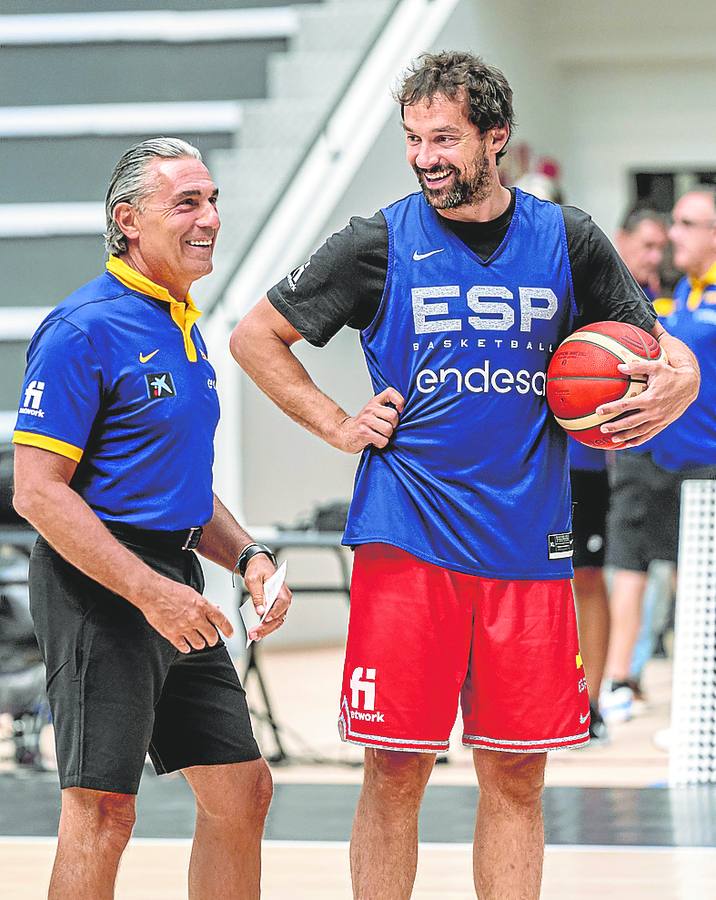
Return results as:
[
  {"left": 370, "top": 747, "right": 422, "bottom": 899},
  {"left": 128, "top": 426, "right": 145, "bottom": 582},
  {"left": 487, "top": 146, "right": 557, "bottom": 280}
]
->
[{"left": 0, "top": 835, "right": 716, "bottom": 855}]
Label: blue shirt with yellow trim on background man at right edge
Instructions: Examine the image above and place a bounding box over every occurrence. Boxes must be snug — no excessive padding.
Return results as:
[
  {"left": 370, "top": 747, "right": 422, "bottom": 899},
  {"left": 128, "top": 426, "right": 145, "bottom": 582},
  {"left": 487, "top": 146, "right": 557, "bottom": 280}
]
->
[{"left": 647, "top": 263, "right": 716, "bottom": 471}]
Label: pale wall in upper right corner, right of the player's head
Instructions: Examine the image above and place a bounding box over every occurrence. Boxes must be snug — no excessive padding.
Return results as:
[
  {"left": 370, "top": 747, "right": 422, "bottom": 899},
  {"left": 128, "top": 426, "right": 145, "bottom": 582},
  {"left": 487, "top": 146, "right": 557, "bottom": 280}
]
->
[{"left": 540, "top": 0, "right": 716, "bottom": 233}]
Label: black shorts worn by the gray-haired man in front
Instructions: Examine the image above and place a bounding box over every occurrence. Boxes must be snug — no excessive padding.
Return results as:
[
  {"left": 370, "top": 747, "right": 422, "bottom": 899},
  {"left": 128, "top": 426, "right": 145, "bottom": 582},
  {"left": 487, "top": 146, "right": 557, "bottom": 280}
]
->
[{"left": 30, "top": 538, "right": 260, "bottom": 794}]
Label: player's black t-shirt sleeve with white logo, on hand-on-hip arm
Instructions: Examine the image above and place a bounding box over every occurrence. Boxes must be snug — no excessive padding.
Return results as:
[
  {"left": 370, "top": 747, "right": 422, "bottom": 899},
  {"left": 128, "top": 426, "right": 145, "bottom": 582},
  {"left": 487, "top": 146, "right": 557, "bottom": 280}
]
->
[{"left": 268, "top": 212, "right": 388, "bottom": 347}]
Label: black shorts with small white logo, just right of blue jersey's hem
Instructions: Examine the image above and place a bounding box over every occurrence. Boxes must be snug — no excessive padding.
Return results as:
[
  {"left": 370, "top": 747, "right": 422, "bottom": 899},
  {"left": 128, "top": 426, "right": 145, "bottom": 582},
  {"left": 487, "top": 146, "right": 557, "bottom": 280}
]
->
[{"left": 569, "top": 469, "right": 609, "bottom": 569}]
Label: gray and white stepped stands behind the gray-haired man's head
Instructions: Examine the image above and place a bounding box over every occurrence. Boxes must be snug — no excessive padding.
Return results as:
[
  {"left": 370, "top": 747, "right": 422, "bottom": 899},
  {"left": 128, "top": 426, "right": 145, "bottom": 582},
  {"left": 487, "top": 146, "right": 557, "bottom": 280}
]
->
[{"left": 0, "top": 0, "right": 396, "bottom": 428}]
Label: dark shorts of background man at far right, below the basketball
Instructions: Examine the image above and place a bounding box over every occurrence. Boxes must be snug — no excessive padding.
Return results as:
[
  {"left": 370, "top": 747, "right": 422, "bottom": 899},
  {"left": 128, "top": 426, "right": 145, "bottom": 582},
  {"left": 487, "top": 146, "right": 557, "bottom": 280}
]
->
[{"left": 607, "top": 450, "right": 716, "bottom": 572}]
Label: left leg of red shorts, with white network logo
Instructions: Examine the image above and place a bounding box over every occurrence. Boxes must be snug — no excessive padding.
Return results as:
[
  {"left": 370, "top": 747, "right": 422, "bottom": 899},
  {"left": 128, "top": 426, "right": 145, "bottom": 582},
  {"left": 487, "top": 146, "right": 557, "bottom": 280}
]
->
[{"left": 338, "top": 544, "right": 472, "bottom": 753}]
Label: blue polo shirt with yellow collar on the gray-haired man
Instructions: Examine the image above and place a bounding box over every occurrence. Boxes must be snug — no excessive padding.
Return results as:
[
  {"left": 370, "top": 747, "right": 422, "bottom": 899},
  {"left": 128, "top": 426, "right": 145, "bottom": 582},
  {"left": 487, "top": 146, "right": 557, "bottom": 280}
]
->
[{"left": 13, "top": 257, "right": 219, "bottom": 531}]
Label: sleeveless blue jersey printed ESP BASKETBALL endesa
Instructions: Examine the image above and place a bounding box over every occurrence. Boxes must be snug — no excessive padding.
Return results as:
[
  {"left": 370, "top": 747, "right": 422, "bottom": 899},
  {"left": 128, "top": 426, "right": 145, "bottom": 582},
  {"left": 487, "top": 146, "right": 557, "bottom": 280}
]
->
[{"left": 345, "top": 191, "right": 576, "bottom": 579}]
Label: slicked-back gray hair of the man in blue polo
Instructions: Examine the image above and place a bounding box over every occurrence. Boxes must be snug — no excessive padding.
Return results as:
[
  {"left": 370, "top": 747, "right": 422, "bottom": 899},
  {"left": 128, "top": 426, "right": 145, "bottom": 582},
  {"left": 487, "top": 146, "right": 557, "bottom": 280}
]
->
[{"left": 104, "top": 137, "right": 201, "bottom": 256}]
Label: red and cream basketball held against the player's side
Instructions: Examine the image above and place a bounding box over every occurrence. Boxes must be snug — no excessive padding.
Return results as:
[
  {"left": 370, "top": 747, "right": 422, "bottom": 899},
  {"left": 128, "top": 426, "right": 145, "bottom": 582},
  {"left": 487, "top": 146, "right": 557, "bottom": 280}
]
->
[{"left": 547, "top": 322, "right": 666, "bottom": 450}]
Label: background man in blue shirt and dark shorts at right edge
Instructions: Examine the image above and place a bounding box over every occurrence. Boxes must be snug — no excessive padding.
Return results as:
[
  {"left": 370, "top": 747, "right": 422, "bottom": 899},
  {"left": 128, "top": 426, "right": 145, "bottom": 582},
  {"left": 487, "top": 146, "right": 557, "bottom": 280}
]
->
[{"left": 602, "top": 189, "right": 716, "bottom": 720}]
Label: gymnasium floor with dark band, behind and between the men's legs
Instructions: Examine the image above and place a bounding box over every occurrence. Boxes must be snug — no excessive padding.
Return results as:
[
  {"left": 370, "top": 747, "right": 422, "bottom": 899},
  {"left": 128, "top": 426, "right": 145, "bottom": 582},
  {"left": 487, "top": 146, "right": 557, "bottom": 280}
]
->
[{"left": 0, "top": 648, "right": 716, "bottom": 900}]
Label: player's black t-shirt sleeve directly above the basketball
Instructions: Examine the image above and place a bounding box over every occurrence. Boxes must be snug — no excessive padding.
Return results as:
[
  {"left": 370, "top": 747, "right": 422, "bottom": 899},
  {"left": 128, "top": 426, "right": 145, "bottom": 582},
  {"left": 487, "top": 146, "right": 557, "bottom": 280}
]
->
[{"left": 562, "top": 206, "right": 656, "bottom": 331}]
